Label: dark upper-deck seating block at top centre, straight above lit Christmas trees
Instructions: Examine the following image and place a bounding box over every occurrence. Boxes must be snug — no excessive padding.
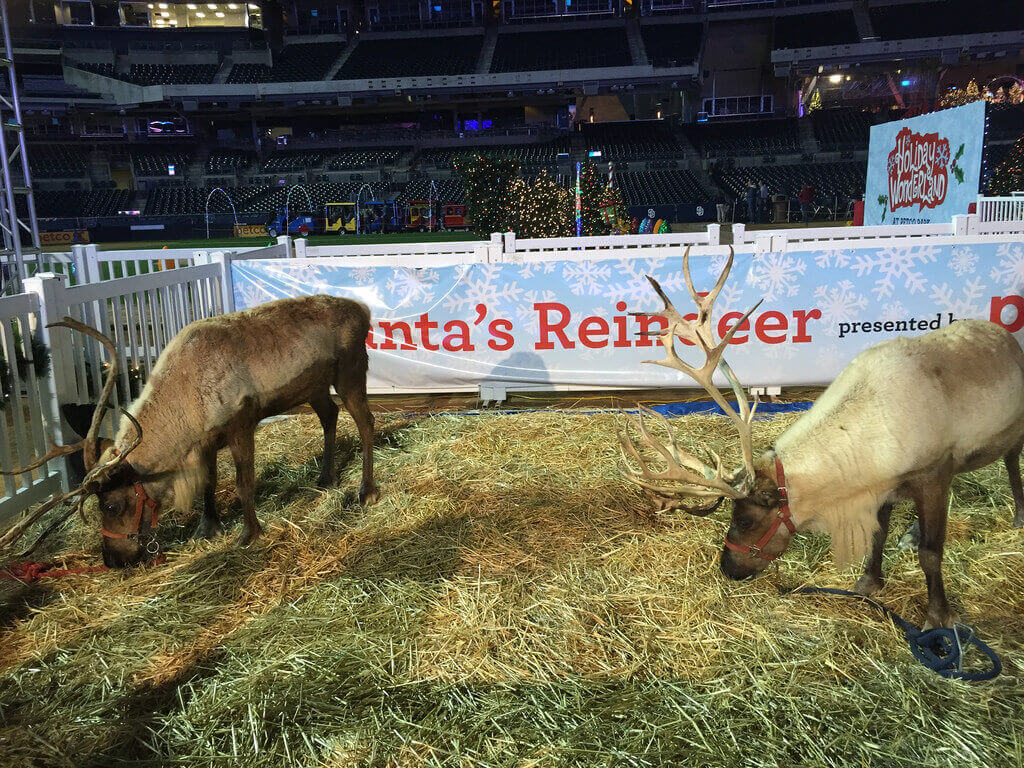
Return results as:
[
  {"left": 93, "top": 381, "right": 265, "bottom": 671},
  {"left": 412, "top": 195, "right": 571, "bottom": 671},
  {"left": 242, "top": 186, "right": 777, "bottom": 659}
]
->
[{"left": 490, "top": 28, "right": 632, "bottom": 72}]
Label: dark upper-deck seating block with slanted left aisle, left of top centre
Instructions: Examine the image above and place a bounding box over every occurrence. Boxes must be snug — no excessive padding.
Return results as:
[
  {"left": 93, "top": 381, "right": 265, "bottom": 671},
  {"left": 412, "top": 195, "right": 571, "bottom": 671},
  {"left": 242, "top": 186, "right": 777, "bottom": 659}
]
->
[{"left": 335, "top": 35, "right": 483, "bottom": 80}]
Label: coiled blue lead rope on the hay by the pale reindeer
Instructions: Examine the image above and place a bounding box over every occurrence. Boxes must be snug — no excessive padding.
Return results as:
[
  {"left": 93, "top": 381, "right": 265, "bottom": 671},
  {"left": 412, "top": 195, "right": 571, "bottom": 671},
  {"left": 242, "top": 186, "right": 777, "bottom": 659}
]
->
[{"left": 781, "top": 587, "right": 1002, "bottom": 682}]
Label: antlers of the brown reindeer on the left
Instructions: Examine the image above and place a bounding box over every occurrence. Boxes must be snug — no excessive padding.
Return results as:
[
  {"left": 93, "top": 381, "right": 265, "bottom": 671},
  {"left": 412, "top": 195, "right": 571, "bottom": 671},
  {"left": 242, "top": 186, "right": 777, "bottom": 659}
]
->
[{"left": 0, "top": 317, "right": 142, "bottom": 557}]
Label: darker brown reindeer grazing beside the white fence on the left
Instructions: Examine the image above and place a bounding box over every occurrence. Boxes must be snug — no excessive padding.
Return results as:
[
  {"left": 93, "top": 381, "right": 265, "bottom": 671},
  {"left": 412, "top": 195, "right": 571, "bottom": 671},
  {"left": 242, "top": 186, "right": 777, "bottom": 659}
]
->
[{"left": 0, "top": 296, "right": 378, "bottom": 567}]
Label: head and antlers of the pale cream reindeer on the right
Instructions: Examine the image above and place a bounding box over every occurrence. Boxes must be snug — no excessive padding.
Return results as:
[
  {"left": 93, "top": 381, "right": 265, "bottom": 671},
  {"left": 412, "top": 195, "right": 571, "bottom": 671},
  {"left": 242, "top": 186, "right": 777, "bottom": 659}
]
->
[{"left": 618, "top": 248, "right": 793, "bottom": 579}]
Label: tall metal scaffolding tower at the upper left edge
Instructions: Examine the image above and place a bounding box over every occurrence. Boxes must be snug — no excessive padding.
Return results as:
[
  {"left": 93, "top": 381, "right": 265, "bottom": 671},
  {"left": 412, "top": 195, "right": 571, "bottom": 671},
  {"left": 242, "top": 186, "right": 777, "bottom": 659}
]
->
[{"left": 0, "top": 0, "right": 41, "bottom": 293}]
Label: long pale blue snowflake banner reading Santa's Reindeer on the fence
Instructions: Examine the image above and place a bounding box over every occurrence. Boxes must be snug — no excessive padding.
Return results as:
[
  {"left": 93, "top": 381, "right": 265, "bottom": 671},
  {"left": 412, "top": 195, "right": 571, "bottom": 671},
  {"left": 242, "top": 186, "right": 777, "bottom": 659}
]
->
[{"left": 231, "top": 241, "right": 1024, "bottom": 392}]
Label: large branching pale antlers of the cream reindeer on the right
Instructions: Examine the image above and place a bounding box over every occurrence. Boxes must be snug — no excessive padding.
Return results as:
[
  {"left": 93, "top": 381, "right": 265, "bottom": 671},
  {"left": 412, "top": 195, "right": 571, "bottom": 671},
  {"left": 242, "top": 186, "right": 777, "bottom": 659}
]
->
[{"left": 620, "top": 247, "right": 763, "bottom": 515}]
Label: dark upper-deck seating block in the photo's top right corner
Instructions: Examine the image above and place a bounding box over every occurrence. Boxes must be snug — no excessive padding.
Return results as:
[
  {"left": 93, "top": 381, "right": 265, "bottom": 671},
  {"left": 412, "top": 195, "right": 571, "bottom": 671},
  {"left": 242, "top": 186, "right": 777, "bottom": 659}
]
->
[{"left": 869, "top": 0, "right": 1024, "bottom": 40}]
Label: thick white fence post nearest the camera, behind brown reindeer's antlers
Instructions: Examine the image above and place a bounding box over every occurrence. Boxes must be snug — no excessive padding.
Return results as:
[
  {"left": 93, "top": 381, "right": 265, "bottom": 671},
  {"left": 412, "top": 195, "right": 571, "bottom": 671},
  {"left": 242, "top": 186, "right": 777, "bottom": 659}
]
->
[{"left": 25, "top": 272, "right": 80, "bottom": 490}]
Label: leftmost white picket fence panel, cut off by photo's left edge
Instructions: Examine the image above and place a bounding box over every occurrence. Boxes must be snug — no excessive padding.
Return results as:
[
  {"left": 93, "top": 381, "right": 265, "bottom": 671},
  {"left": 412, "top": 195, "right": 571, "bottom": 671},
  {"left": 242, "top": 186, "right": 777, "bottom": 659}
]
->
[{"left": 0, "top": 293, "right": 61, "bottom": 522}]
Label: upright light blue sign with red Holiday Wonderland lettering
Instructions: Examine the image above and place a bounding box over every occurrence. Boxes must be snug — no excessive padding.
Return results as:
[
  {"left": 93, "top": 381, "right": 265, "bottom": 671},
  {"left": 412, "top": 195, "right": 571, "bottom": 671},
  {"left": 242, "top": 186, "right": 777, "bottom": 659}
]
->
[{"left": 864, "top": 101, "right": 985, "bottom": 224}]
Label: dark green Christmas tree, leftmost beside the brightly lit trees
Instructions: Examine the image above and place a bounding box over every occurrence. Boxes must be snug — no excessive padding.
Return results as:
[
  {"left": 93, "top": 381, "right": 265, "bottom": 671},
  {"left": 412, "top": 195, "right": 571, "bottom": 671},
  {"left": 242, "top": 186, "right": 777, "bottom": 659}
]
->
[{"left": 456, "top": 154, "right": 519, "bottom": 237}]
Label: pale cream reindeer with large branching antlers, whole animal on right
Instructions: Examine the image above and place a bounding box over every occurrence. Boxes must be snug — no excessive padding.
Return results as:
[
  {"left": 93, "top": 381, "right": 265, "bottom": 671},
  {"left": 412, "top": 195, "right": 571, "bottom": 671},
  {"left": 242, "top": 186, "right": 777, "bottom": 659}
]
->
[{"left": 620, "top": 249, "right": 1024, "bottom": 627}]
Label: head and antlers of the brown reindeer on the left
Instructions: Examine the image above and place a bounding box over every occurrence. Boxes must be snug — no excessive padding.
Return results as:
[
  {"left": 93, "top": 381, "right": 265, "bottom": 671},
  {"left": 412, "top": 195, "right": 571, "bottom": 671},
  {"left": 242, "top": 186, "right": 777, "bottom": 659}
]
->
[{"left": 0, "top": 317, "right": 150, "bottom": 567}]
